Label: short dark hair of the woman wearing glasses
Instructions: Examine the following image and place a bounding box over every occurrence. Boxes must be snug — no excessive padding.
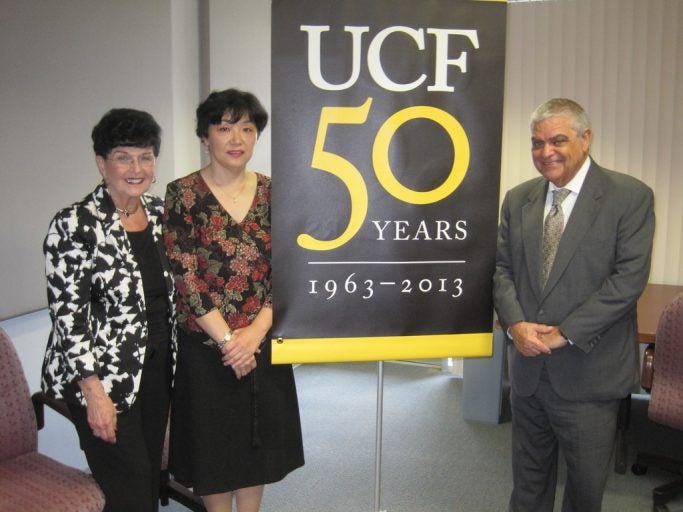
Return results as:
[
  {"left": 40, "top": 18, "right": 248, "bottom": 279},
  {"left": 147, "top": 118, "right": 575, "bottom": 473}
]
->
[{"left": 92, "top": 108, "right": 161, "bottom": 158}]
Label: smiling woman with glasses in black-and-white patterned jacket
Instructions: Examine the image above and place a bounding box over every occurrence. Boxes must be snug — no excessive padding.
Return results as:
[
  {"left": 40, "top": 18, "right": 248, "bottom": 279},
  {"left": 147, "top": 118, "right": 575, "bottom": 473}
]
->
[{"left": 42, "top": 109, "right": 175, "bottom": 512}]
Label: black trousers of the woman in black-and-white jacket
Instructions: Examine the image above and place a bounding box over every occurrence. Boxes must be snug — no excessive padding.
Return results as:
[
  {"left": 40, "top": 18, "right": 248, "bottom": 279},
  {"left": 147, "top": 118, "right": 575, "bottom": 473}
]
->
[{"left": 69, "top": 341, "right": 172, "bottom": 512}]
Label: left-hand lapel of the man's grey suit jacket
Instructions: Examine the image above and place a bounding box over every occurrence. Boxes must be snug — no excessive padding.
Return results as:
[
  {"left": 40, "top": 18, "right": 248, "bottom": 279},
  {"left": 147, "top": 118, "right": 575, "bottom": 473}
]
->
[{"left": 522, "top": 178, "right": 548, "bottom": 296}]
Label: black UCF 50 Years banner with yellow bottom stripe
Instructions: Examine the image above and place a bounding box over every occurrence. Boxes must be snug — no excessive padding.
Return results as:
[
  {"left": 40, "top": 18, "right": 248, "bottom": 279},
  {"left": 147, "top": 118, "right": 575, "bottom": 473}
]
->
[{"left": 272, "top": 0, "right": 506, "bottom": 363}]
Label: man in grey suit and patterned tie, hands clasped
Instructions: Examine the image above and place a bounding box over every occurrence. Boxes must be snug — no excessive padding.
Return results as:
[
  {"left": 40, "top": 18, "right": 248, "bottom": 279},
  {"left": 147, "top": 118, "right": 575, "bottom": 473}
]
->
[{"left": 494, "top": 98, "right": 655, "bottom": 512}]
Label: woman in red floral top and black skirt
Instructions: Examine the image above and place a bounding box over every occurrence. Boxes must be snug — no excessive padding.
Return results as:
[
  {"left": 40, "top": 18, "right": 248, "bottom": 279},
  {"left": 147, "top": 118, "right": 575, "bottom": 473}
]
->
[{"left": 164, "top": 89, "right": 304, "bottom": 512}]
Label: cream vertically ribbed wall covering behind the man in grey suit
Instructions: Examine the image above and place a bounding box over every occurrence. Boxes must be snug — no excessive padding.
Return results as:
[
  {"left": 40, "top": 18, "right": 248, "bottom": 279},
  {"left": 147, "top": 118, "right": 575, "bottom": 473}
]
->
[{"left": 501, "top": 0, "right": 683, "bottom": 284}]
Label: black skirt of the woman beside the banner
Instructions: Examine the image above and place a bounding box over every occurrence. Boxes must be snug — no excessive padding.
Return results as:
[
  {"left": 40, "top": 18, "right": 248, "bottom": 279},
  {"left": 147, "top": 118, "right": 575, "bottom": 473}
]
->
[{"left": 169, "top": 329, "right": 304, "bottom": 496}]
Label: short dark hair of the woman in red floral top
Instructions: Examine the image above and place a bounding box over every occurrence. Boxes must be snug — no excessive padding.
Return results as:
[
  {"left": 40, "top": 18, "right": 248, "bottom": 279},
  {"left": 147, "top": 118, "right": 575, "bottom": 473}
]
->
[{"left": 196, "top": 89, "right": 268, "bottom": 139}]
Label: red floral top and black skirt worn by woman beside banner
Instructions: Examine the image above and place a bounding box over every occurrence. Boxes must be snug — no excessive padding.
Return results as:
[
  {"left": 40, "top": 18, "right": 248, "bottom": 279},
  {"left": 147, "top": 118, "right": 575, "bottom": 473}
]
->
[{"left": 164, "top": 171, "right": 304, "bottom": 495}]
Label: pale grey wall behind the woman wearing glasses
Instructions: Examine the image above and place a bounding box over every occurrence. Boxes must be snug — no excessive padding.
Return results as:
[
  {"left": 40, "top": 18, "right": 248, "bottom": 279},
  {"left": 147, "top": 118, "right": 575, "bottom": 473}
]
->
[{"left": 0, "top": 0, "right": 199, "bottom": 318}]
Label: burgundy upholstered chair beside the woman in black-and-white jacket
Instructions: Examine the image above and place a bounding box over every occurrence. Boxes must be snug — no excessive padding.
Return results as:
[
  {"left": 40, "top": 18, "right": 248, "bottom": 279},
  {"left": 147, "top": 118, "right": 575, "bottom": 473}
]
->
[{"left": 0, "top": 328, "right": 104, "bottom": 512}]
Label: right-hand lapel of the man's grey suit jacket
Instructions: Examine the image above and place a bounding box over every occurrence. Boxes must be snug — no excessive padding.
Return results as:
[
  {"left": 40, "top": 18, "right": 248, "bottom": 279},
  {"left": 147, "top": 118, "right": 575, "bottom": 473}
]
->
[{"left": 543, "top": 162, "right": 604, "bottom": 295}]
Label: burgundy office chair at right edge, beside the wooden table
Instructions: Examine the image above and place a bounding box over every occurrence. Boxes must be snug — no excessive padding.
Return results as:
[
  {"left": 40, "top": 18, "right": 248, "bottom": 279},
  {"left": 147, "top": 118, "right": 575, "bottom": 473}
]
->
[{"left": 631, "top": 294, "right": 683, "bottom": 512}]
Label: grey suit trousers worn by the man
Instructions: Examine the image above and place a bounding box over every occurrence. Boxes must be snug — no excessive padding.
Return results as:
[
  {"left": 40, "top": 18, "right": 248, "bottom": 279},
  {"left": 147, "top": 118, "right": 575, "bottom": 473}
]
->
[{"left": 510, "top": 369, "right": 620, "bottom": 512}]
